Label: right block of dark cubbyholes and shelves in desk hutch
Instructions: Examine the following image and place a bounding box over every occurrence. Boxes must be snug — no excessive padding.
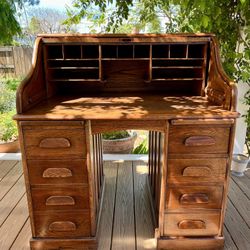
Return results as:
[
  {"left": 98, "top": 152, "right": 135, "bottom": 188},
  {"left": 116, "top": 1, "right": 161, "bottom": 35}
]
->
[{"left": 151, "top": 44, "right": 206, "bottom": 82}]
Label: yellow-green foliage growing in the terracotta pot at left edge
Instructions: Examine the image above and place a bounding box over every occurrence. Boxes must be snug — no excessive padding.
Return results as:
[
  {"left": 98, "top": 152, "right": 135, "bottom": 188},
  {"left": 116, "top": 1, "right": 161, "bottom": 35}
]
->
[{"left": 0, "top": 110, "right": 17, "bottom": 142}]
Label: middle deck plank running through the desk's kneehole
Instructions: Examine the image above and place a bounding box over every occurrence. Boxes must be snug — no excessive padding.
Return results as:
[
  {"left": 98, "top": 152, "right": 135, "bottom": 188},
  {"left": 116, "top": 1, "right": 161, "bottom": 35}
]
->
[{"left": 112, "top": 161, "right": 135, "bottom": 250}]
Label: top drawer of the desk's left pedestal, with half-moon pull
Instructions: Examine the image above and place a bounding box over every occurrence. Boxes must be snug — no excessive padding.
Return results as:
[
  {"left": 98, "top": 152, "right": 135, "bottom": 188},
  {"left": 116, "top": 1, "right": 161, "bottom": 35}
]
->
[{"left": 23, "top": 126, "right": 86, "bottom": 159}]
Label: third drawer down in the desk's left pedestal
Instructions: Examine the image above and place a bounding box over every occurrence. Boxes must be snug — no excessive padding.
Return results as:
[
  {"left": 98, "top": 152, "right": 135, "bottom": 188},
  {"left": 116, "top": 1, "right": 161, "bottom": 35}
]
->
[{"left": 31, "top": 187, "right": 89, "bottom": 211}]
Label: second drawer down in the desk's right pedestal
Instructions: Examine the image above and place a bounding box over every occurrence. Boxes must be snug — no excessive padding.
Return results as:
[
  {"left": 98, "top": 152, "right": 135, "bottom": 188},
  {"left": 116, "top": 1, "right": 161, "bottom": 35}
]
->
[{"left": 168, "top": 158, "right": 227, "bottom": 183}]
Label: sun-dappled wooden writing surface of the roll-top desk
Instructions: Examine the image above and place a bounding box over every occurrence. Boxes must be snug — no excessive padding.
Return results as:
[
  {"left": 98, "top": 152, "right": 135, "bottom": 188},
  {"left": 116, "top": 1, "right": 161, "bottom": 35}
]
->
[{"left": 15, "top": 95, "right": 238, "bottom": 120}]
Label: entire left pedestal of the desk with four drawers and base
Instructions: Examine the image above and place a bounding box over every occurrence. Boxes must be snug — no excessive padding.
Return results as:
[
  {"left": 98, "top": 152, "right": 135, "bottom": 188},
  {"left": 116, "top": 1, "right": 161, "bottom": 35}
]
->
[{"left": 18, "top": 121, "right": 103, "bottom": 250}]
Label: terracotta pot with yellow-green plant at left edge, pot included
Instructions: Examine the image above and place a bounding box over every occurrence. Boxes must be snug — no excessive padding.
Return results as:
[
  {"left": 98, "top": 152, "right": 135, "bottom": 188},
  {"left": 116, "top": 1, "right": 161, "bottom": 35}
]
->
[{"left": 0, "top": 111, "right": 19, "bottom": 153}]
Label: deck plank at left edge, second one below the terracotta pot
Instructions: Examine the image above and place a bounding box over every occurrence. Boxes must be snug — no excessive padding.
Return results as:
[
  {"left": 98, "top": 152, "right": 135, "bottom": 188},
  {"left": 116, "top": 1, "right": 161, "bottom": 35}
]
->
[{"left": 0, "top": 162, "right": 23, "bottom": 201}]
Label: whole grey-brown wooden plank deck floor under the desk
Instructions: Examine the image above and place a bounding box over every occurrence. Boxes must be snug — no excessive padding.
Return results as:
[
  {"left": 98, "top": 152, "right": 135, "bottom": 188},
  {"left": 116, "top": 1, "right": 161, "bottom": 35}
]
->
[{"left": 0, "top": 161, "right": 250, "bottom": 250}]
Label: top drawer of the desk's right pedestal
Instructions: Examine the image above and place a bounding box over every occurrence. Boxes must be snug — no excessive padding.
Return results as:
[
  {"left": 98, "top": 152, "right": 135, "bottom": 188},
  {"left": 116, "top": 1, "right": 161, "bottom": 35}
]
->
[{"left": 169, "top": 126, "right": 230, "bottom": 154}]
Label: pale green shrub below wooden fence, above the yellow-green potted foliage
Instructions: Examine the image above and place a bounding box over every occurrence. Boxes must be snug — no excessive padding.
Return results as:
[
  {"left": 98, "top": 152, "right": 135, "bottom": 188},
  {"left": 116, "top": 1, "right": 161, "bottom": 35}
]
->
[{"left": 0, "top": 82, "right": 16, "bottom": 113}]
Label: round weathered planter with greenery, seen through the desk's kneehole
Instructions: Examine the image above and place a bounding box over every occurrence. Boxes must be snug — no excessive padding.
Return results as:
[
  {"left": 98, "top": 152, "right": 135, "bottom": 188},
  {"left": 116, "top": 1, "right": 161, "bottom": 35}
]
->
[{"left": 102, "top": 130, "right": 137, "bottom": 154}]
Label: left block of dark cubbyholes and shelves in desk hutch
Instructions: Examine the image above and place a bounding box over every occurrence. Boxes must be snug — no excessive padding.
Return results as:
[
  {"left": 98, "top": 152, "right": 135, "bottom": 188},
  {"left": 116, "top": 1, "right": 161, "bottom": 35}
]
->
[{"left": 47, "top": 44, "right": 101, "bottom": 82}]
